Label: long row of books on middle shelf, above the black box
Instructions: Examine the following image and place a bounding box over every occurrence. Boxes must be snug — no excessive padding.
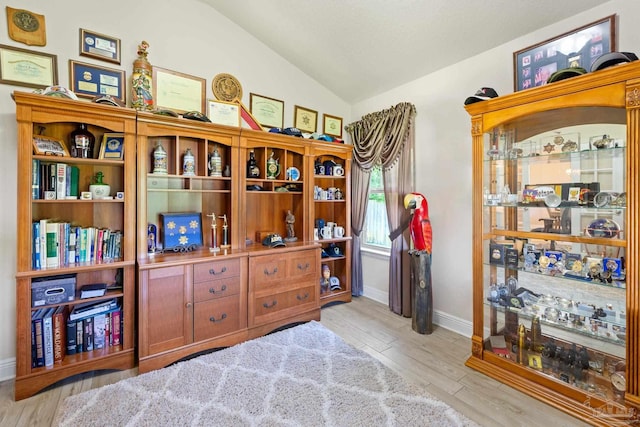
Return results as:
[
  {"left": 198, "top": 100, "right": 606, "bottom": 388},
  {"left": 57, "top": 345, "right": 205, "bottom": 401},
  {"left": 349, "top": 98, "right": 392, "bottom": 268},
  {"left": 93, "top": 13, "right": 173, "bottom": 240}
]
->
[{"left": 32, "top": 219, "right": 122, "bottom": 270}]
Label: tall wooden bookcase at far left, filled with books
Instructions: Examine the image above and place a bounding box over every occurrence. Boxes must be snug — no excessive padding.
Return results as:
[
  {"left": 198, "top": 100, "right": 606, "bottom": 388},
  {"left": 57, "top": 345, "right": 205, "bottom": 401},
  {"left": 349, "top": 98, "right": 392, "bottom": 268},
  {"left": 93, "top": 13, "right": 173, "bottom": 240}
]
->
[{"left": 13, "top": 92, "right": 136, "bottom": 400}]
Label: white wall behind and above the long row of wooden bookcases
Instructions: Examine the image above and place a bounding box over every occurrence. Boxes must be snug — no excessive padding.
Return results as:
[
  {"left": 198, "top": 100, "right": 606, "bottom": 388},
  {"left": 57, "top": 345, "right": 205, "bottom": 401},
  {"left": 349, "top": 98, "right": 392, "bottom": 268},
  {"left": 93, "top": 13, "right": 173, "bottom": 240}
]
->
[{"left": 0, "top": 0, "right": 350, "bottom": 380}]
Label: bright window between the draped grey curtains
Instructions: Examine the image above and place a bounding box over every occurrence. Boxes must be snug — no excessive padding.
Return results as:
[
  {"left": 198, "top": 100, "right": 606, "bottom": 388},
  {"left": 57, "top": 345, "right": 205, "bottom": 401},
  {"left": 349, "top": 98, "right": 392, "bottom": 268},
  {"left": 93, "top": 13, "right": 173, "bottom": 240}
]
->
[{"left": 364, "top": 166, "right": 391, "bottom": 249}]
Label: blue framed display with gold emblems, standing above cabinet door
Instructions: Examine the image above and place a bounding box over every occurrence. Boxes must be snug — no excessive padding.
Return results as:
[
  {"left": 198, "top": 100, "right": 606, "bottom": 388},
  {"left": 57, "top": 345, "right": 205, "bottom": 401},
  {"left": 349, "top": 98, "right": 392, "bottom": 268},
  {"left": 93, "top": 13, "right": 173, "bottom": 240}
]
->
[{"left": 160, "top": 212, "right": 202, "bottom": 252}]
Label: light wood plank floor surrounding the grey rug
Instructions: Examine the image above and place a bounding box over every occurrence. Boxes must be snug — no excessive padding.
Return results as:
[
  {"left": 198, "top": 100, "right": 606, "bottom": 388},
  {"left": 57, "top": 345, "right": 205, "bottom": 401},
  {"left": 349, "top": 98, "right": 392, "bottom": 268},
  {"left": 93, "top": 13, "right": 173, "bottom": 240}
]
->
[{"left": 0, "top": 297, "right": 587, "bottom": 427}]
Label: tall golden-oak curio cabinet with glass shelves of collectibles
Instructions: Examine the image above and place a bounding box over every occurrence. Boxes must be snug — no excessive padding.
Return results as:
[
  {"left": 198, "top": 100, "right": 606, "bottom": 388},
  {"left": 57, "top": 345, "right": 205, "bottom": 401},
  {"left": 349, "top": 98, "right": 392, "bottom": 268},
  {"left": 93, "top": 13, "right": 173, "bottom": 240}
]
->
[{"left": 465, "top": 62, "right": 640, "bottom": 425}]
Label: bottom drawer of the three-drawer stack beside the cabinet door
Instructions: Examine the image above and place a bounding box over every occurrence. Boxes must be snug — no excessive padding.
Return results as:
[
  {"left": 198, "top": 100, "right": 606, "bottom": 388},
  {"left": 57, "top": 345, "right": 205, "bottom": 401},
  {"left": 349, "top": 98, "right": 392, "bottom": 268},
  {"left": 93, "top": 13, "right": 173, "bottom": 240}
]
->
[{"left": 193, "top": 295, "right": 240, "bottom": 342}]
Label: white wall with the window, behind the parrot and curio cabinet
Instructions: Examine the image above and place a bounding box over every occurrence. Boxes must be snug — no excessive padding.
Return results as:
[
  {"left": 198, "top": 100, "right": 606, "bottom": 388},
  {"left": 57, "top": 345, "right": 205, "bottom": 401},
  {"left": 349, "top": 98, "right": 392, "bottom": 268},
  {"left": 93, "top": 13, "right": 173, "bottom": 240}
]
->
[{"left": 352, "top": 0, "right": 640, "bottom": 336}]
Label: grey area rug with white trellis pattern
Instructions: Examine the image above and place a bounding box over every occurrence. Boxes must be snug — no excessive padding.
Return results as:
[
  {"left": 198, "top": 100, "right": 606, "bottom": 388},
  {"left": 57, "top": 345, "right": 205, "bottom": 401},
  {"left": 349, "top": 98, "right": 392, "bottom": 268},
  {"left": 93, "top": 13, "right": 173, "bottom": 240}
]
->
[{"left": 53, "top": 321, "right": 476, "bottom": 427}]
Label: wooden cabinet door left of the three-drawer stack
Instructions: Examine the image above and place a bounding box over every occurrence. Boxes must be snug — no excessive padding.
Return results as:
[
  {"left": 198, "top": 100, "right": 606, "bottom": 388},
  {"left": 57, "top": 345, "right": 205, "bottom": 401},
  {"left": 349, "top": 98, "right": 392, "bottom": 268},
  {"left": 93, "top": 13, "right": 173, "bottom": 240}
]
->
[{"left": 140, "top": 266, "right": 193, "bottom": 356}]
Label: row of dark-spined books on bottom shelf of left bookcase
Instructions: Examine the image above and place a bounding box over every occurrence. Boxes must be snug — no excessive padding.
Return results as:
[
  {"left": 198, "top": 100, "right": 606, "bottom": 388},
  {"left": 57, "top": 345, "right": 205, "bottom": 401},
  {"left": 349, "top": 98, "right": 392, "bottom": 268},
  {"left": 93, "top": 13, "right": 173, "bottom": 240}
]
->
[{"left": 31, "top": 298, "right": 123, "bottom": 368}]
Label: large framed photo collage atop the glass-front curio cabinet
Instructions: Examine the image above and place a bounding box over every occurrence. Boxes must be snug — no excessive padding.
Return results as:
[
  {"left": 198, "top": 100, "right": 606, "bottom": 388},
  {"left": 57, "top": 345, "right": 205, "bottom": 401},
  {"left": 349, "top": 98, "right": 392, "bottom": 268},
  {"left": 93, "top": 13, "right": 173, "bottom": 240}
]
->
[{"left": 513, "top": 15, "right": 616, "bottom": 92}]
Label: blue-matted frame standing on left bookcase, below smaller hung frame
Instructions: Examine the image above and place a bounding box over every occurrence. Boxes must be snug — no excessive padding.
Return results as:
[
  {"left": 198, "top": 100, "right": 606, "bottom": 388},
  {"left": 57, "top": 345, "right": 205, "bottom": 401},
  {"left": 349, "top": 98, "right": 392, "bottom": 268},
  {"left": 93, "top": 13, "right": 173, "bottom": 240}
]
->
[{"left": 69, "top": 59, "right": 127, "bottom": 104}]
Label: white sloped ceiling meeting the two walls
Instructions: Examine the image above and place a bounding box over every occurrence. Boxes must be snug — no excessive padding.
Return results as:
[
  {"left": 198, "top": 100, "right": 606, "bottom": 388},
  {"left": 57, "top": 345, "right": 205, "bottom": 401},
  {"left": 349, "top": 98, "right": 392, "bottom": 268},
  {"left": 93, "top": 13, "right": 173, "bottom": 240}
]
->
[{"left": 200, "top": 0, "right": 604, "bottom": 103}]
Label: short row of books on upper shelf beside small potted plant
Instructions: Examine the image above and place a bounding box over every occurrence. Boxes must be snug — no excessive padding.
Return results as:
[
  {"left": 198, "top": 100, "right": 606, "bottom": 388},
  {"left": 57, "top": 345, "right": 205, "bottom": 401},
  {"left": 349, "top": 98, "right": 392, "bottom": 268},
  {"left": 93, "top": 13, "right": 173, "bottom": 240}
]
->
[{"left": 31, "top": 159, "right": 80, "bottom": 200}]
